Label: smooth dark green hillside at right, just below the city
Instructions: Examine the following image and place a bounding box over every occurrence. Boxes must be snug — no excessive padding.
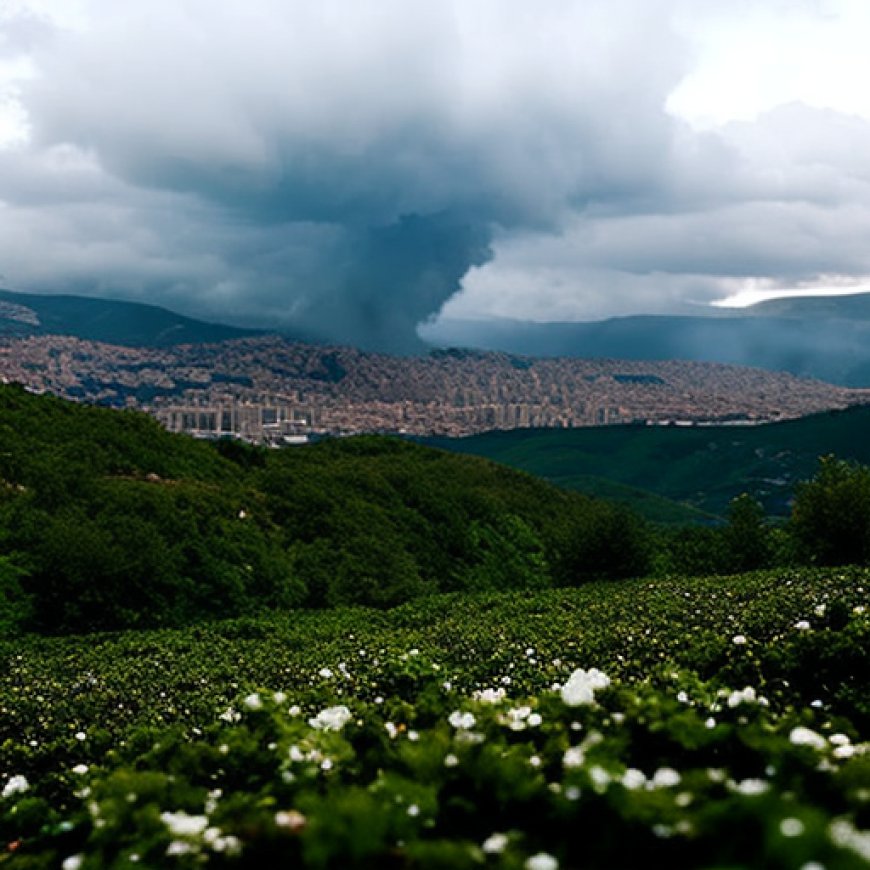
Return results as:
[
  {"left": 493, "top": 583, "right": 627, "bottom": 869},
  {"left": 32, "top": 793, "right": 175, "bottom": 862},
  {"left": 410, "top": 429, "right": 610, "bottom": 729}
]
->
[{"left": 427, "top": 407, "right": 870, "bottom": 519}]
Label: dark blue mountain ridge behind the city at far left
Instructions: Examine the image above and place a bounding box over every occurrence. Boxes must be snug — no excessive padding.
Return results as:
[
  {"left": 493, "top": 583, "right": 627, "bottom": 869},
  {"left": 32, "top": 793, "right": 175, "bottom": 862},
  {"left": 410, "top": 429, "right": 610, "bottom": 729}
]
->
[{"left": 0, "top": 290, "right": 263, "bottom": 347}]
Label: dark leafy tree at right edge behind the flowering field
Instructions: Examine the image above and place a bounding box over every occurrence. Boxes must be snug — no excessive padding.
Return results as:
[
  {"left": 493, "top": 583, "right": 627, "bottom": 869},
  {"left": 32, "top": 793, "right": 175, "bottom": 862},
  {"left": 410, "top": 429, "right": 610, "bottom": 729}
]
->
[{"left": 791, "top": 456, "right": 870, "bottom": 565}]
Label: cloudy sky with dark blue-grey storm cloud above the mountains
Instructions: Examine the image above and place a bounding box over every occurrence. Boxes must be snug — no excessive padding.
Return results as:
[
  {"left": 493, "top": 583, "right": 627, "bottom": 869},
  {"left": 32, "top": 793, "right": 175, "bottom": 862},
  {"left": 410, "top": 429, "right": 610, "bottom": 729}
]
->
[{"left": 0, "top": 0, "right": 870, "bottom": 351}]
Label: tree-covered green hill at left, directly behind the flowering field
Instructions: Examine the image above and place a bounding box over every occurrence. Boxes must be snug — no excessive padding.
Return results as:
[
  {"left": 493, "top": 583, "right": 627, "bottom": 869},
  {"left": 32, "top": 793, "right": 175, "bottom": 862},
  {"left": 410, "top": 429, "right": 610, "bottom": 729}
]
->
[{"left": 0, "top": 386, "right": 643, "bottom": 631}]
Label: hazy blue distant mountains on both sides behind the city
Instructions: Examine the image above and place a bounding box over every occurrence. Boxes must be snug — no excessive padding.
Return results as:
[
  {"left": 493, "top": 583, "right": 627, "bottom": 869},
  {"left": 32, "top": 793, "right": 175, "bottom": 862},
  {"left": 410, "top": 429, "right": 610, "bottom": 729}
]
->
[{"left": 0, "top": 290, "right": 870, "bottom": 387}]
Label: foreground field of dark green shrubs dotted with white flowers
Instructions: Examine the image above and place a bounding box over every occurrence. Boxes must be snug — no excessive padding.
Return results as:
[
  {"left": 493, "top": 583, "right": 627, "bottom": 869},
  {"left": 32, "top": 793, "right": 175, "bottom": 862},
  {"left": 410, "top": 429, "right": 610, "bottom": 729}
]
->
[{"left": 0, "top": 570, "right": 870, "bottom": 870}]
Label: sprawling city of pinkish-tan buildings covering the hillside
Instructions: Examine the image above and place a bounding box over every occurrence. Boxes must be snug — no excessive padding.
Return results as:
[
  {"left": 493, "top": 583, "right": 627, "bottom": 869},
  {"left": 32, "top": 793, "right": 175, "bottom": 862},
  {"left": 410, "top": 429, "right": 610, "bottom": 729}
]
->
[{"left": 0, "top": 336, "right": 870, "bottom": 442}]
